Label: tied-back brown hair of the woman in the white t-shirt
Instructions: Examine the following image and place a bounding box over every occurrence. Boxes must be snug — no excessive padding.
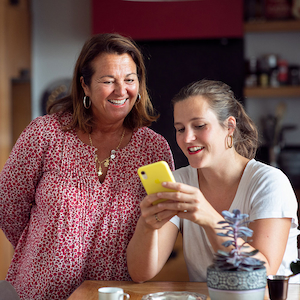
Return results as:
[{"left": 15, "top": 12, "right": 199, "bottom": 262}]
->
[{"left": 172, "top": 79, "right": 259, "bottom": 159}]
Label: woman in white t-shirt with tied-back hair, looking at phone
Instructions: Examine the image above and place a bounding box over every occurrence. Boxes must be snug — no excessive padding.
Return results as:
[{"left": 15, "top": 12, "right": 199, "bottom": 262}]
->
[{"left": 127, "top": 80, "right": 299, "bottom": 282}]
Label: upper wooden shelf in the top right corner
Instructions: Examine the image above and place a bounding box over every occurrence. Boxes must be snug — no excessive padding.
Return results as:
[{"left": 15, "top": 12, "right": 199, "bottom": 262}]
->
[{"left": 244, "top": 20, "right": 300, "bottom": 32}]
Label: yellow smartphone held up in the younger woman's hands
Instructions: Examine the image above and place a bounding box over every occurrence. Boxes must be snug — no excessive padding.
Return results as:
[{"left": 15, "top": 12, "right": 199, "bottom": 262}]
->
[{"left": 138, "top": 161, "right": 176, "bottom": 205}]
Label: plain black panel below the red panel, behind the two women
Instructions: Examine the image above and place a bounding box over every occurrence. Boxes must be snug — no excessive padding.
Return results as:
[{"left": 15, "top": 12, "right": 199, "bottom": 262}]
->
[{"left": 138, "top": 38, "right": 244, "bottom": 168}]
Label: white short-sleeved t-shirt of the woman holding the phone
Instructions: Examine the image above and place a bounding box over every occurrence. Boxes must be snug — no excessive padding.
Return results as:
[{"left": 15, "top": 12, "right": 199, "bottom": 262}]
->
[{"left": 171, "top": 159, "right": 300, "bottom": 282}]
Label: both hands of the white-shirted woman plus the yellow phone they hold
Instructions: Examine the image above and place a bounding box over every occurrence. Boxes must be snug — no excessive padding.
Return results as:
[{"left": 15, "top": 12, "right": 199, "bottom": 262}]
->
[{"left": 138, "top": 162, "right": 216, "bottom": 228}]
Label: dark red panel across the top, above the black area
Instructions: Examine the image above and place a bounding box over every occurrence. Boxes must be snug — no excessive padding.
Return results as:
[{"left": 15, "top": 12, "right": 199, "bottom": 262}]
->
[{"left": 92, "top": 0, "right": 243, "bottom": 40}]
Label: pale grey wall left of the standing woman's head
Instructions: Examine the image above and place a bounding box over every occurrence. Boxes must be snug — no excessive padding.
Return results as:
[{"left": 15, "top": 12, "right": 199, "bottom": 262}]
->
[{"left": 31, "top": 0, "right": 92, "bottom": 118}]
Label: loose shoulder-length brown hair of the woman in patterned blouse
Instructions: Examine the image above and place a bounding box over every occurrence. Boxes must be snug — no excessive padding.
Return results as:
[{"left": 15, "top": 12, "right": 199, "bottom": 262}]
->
[{"left": 47, "top": 33, "right": 158, "bottom": 133}]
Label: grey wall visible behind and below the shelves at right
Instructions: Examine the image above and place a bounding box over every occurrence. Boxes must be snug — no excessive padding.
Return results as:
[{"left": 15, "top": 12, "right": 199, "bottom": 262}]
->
[{"left": 245, "top": 31, "right": 300, "bottom": 145}]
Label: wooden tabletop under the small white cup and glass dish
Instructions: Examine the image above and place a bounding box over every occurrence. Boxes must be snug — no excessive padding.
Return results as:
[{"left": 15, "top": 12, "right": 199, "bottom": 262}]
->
[{"left": 68, "top": 280, "right": 300, "bottom": 300}]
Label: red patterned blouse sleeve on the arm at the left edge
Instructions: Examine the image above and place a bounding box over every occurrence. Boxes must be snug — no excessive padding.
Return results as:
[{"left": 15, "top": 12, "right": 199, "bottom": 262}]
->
[{"left": 0, "top": 117, "right": 45, "bottom": 247}]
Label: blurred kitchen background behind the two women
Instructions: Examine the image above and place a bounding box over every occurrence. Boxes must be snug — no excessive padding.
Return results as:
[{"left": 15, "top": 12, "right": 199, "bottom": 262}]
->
[{"left": 0, "top": 0, "right": 300, "bottom": 279}]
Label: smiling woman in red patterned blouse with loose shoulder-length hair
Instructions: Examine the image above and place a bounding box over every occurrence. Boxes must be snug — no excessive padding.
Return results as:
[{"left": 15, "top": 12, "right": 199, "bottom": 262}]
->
[{"left": 0, "top": 34, "right": 174, "bottom": 299}]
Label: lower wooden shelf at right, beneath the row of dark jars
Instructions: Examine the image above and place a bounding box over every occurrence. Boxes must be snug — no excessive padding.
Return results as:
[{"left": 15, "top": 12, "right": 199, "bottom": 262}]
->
[{"left": 244, "top": 86, "right": 300, "bottom": 98}]
